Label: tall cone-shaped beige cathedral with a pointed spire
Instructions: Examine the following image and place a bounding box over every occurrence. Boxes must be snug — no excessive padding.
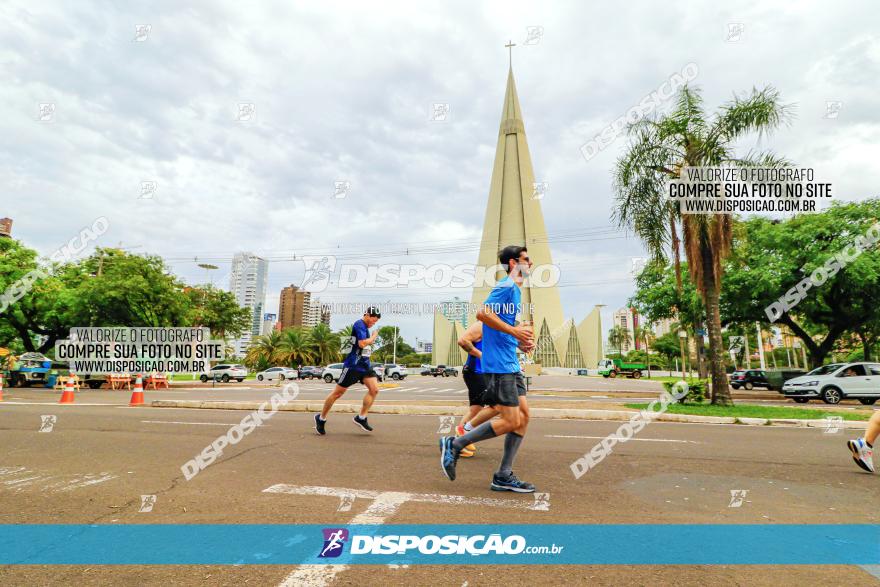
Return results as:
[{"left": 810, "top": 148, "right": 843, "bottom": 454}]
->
[{"left": 432, "top": 57, "right": 602, "bottom": 368}]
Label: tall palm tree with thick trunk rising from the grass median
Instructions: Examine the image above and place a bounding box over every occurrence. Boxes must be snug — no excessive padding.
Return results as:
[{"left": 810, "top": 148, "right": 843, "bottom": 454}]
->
[{"left": 614, "top": 86, "right": 790, "bottom": 405}]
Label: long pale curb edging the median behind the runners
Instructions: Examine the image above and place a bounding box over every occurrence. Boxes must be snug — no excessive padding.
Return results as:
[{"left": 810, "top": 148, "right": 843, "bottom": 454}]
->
[{"left": 151, "top": 400, "right": 868, "bottom": 429}]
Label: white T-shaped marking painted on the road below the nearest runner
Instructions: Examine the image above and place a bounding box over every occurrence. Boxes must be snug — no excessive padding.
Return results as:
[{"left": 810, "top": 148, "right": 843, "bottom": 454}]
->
[{"left": 263, "top": 483, "right": 550, "bottom": 587}]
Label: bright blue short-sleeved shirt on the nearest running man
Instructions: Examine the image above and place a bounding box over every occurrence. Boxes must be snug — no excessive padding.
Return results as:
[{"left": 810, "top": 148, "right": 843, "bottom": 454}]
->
[{"left": 482, "top": 276, "right": 522, "bottom": 373}]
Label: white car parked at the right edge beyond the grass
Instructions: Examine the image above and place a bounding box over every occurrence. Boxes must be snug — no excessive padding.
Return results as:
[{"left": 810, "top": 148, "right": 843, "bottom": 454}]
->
[{"left": 782, "top": 363, "right": 880, "bottom": 406}]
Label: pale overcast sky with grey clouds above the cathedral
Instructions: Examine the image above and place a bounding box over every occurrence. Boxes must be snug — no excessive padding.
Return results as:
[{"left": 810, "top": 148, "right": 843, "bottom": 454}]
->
[{"left": 0, "top": 0, "right": 880, "bottom": 343}]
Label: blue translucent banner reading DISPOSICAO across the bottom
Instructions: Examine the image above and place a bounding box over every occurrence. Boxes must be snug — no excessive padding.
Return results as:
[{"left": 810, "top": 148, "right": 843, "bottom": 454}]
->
[{"left": 0, "top": 524, "right": 880, "bottom": 565}]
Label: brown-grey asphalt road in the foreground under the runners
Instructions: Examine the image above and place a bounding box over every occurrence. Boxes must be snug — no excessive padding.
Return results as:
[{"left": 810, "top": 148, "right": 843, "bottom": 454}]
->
[{"left": 0, "top": 392, "right": 880, "bottom": 587}]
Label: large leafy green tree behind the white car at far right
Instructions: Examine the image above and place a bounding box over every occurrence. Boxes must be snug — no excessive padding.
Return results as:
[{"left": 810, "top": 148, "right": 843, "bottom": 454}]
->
[{"left": 721, "top": 198, "right": 880, "bottom": 367}]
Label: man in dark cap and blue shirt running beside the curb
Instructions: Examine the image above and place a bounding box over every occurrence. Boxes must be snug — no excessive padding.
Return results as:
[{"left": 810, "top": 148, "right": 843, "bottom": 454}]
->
[{"left": 315, "top": 306, "right": 382, "bottom": 436}]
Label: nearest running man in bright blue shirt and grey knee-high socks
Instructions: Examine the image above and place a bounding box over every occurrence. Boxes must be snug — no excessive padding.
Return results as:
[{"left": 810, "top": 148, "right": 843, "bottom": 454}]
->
[{"left": 440, "top": 245, "right": 535, "bottom": 493}]
